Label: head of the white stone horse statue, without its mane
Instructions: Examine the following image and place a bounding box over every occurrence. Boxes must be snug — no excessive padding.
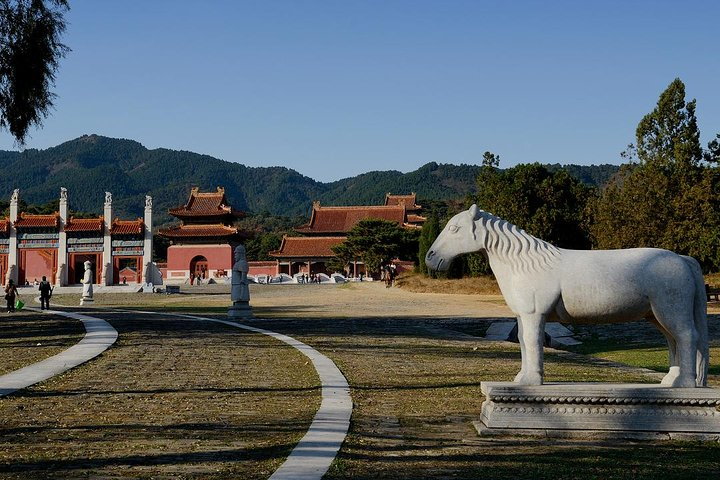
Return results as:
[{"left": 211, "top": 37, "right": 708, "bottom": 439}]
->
[{"left": 425, "top": 205, "right": 480, "bottom": 271}]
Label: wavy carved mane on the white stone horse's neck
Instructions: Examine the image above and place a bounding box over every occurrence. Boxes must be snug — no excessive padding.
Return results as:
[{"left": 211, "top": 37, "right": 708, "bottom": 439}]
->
[{"left": 474, "top": 209, "right": 561, "bottom": 273}]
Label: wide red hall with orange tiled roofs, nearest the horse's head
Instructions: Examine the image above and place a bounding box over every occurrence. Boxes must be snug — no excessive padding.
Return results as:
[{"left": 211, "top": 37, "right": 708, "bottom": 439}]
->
[{"left": 270, "top": 193, "right": 425, "bottom": 276}]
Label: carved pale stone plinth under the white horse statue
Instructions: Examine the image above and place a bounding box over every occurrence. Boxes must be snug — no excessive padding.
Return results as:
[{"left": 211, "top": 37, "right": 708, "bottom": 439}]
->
[{"left": 475, "top": 382, "right": 720, "bottom": 441}]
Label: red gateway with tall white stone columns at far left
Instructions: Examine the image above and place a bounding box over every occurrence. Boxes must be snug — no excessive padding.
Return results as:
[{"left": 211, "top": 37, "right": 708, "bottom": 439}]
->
[{"left": 0, "top": 188, "right": 153, "bottom": 286}]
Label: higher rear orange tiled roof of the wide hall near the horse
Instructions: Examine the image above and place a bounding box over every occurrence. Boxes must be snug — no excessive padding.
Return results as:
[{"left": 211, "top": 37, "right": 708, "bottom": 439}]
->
[{"left": 295, "top": 202, "right": 406, "bottom": 234}]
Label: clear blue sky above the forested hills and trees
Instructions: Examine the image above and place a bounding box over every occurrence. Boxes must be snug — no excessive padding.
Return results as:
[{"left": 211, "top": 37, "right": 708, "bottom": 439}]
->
[{"left": 0, "top": 0, "right": 720, "bottom": 181}]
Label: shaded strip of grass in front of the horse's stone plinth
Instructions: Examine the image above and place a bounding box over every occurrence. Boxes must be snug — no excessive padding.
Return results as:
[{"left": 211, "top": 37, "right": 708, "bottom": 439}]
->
[{"left": 324, "top": 436, "right": 720, "bottom": 480}]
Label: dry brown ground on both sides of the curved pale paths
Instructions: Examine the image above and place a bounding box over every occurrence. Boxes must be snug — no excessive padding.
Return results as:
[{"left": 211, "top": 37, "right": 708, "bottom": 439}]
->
[{"left": 0, "top": 284, "right": 720, "bottom": 479}]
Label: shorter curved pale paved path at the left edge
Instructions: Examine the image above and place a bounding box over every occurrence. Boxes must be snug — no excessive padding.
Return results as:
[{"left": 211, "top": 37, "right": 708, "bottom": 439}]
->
[{"left": 0, "top": 307, "right": 118, "bottom": 397}]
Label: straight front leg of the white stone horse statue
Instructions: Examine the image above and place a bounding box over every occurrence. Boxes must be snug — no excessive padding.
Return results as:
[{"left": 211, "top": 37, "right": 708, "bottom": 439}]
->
[{"left": 515, "top": 314, "right": 546, "bottom": 385}]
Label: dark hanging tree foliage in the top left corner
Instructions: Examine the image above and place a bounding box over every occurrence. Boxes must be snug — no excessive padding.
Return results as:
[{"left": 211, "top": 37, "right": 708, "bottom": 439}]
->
[{"left": 0, "top": 0, "right": 70, "bottom": 145}]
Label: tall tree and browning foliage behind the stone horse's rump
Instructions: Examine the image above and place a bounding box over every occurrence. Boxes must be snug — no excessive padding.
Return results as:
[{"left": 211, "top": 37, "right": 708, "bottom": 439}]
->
[{"left": 593, "top": 79, "right": 720, "bottom": 270}]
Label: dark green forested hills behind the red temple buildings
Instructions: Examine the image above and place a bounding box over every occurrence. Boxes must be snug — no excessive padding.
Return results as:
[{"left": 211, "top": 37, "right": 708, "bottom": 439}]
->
[{"left": 0, "top": 135, "right": 617, "bottom": 224}]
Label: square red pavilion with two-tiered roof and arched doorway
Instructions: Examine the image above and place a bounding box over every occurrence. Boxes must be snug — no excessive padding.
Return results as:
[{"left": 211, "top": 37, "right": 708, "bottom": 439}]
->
[{"left": 158, "top": 187, "right": 245, "bottom": 283}]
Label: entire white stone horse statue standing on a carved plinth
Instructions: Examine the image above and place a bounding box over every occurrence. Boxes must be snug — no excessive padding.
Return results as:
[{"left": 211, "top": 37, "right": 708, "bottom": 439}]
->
[{"left": 425, "top": 205, "right": 709, "bottom": 387}]
